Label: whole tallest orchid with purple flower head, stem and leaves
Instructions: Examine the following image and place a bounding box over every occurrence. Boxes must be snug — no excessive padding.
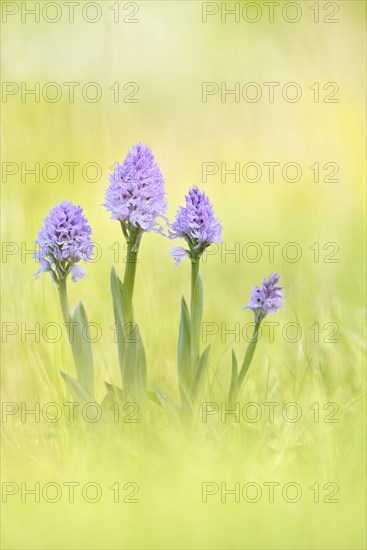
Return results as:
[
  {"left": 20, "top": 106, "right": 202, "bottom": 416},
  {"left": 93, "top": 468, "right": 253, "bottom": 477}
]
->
[{"left": 104, "top": 143, "right": 167, "bottom": 402}]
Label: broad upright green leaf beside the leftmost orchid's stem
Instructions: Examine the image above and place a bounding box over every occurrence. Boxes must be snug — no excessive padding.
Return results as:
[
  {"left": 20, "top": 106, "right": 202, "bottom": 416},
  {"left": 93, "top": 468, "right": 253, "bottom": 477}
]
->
[{"left": 70, "top": 302, "right": 94, "bottom": 395}]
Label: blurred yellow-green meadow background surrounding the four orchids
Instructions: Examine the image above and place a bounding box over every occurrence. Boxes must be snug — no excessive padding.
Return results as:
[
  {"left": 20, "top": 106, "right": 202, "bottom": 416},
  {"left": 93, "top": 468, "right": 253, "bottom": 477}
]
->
[{"left": 1, "top": 0, "right": 366, "bottom": 549}]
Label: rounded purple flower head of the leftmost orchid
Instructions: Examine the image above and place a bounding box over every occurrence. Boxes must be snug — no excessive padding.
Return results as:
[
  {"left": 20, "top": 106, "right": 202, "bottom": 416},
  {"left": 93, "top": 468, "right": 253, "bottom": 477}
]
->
[{"left": 34, "top": 201, "right": 94, "bottom": 284}]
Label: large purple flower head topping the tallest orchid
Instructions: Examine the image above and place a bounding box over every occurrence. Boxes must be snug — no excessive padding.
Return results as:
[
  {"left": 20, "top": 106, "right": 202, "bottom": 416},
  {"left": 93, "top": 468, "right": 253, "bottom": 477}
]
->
[{"left": 104, "top": 143, "right": 167, "bottom": 233}]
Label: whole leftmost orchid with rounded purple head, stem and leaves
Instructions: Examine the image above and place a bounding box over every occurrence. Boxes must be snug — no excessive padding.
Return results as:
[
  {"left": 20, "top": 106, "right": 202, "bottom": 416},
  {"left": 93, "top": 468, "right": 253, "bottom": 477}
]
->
[{"left": 34, "top": 201, "right": 94, "bottom": 399}]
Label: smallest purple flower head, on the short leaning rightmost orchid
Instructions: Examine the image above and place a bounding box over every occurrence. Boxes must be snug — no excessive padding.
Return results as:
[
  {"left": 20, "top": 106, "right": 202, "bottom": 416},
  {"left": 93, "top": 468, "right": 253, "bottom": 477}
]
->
[{"left": 243, "top": 273, "right": 285, "bottom": 322}]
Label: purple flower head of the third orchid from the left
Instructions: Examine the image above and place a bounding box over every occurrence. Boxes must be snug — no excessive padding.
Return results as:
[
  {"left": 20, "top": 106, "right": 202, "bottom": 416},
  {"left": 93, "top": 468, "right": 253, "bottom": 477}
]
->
[{"left": 169, "top": 185, "right": 222, "bottom": 265}]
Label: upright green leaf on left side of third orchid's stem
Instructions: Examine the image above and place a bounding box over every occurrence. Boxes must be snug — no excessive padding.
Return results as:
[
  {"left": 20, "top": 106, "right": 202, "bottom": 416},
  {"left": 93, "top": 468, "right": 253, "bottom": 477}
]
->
[{"left": 177, "top": 296, "right": 191, "bottom": 402}]
